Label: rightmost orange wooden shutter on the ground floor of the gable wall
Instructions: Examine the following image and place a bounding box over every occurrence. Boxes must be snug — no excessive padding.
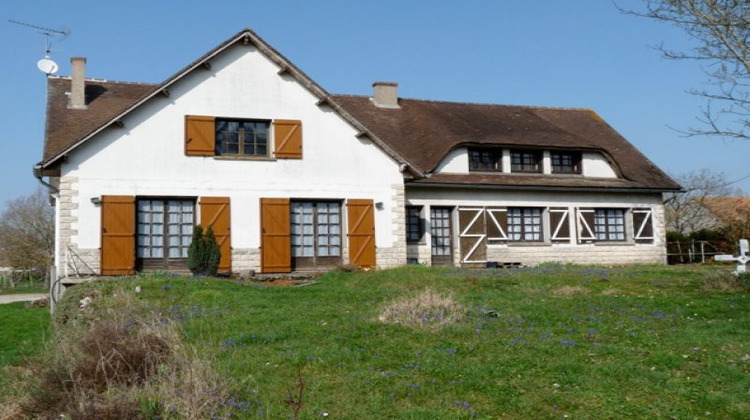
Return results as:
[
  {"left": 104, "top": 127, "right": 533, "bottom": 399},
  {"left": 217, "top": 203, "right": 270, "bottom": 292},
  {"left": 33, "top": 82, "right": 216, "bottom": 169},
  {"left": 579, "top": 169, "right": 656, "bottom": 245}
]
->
[{"left": 347, "top": 199, "right": 375, "bottom": 267}]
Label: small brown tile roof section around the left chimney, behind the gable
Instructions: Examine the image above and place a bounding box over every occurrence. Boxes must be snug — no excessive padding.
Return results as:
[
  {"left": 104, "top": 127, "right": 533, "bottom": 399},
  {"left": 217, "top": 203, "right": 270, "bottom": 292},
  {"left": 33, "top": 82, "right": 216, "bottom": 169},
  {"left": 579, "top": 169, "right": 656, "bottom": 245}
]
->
[{"left": 43, "top": 77, "right": 156, "bottom": 161}]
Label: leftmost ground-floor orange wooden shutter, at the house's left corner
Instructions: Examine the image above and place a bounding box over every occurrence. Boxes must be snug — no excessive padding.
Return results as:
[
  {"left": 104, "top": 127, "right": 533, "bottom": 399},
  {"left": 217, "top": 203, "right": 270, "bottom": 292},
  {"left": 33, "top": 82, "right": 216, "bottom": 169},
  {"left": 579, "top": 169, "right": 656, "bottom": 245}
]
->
[{"left": 101, "top": 195, "right": 135, "bottom": 276}]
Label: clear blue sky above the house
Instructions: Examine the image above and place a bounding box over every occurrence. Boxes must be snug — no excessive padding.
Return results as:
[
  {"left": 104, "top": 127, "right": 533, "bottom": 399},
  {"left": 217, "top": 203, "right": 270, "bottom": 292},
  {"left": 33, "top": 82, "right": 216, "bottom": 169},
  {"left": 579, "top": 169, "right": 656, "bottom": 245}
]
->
[{"left": 0, "top": 0, "right": 750, "bottom": 206}]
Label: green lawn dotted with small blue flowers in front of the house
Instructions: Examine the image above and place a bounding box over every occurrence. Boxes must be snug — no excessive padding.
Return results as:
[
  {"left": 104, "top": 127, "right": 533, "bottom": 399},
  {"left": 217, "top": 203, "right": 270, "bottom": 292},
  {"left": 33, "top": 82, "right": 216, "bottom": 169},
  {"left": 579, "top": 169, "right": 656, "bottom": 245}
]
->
[{"left": 81, "top": 266, "right": 750, "bottom": 419}]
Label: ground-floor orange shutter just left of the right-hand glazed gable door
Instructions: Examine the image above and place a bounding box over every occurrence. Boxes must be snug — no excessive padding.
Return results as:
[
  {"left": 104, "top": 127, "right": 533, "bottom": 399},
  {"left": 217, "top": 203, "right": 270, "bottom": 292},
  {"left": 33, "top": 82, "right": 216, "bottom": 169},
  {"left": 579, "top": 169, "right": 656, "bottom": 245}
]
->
[{"left": 260, "top": 198, "right": 292, "bottom": 273}]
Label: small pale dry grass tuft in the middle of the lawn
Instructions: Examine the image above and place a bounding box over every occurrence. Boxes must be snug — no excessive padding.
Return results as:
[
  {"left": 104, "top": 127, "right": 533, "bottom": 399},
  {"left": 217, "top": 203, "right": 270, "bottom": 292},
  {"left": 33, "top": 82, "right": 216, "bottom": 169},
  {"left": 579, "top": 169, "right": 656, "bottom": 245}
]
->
[{"left": 378, "top": 289, "right": 466, "bottom": 329}]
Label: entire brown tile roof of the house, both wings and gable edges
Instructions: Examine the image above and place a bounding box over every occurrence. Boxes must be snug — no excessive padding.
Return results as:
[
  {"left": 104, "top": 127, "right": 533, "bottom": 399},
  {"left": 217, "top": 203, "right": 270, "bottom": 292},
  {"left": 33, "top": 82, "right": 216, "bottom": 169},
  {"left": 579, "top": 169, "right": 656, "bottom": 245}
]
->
[{"left": 41, "top": 29, "right": 680, "bottom": 194}]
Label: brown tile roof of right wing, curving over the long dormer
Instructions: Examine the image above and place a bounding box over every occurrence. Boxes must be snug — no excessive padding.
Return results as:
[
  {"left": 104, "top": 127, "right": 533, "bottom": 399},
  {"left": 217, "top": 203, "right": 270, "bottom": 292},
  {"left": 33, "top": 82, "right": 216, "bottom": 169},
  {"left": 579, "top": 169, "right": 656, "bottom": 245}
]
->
[{"left": 333, "top": 95, "right": 680, "bottom": 190}]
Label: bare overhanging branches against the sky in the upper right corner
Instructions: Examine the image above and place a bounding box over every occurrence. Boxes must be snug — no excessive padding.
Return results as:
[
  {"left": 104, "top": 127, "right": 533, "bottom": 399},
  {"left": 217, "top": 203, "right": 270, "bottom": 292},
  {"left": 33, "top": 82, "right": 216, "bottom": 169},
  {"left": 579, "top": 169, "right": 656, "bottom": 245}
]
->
[{"left": 618, "top": 0, "right": 750, "bottom": 140}]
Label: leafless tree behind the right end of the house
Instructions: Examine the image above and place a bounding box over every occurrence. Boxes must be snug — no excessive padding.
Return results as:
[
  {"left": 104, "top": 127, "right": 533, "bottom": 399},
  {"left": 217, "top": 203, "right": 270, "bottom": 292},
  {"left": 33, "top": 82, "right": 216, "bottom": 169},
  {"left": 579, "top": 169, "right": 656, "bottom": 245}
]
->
[{"left": 664, "top": 169, "right": 742, "bottom": 235}]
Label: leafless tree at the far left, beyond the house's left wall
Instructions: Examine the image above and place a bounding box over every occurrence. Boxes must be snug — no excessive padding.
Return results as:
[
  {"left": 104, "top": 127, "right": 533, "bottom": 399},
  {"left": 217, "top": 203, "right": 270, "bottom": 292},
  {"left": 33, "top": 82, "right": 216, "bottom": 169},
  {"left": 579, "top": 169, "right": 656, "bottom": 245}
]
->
[{"left": 0, "top": 189, "right": 55, "bottom": 272}]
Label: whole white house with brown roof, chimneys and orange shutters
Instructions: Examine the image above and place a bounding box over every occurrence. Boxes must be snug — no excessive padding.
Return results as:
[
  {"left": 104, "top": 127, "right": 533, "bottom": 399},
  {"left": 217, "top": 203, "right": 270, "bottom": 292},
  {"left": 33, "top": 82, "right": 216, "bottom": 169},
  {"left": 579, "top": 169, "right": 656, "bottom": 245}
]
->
[{"left": 35, "top": 29, "right": 680, "bottom": 275}]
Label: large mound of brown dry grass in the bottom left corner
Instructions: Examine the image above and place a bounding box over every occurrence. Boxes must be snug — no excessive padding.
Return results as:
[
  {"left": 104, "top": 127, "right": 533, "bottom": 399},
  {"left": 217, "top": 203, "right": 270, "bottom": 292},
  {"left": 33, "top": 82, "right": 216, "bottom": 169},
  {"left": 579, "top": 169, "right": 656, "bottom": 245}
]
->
[{"left": 0, "top": 290, "right": 229, "bottom": 419}]
